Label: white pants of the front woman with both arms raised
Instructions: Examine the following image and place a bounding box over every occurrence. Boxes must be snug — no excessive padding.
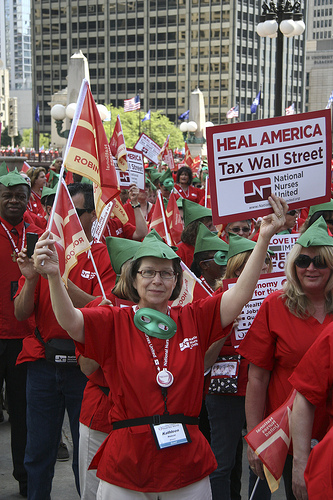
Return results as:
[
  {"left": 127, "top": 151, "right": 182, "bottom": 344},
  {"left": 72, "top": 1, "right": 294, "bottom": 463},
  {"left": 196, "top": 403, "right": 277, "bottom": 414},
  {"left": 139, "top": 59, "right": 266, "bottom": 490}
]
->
[{"left": 96, "top": 476, "right": 212, "bottom": 500}]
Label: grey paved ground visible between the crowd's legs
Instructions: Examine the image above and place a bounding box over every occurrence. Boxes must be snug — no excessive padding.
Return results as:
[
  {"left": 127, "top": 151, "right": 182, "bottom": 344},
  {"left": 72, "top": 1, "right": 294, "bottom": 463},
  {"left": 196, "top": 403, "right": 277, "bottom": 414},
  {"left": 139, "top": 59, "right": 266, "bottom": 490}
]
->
[{"left": 0, "top": 412, "right": 285, "bottom": 500}]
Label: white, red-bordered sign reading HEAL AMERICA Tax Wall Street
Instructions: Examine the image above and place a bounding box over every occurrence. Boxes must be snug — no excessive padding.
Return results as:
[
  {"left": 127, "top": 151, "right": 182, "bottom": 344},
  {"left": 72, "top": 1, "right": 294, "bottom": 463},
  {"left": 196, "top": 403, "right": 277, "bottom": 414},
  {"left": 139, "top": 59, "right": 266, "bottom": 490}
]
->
[{"left": 206, "top": 109, "right": 332, "bottom": 224}]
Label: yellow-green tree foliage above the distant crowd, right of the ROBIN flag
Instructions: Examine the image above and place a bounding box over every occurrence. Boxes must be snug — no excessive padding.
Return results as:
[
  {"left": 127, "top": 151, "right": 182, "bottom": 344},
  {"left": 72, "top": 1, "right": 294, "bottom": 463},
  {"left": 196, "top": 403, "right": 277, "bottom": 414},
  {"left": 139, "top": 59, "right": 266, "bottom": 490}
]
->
[{"left": 104, "top": 104, "right": 184, "bottom": 149}]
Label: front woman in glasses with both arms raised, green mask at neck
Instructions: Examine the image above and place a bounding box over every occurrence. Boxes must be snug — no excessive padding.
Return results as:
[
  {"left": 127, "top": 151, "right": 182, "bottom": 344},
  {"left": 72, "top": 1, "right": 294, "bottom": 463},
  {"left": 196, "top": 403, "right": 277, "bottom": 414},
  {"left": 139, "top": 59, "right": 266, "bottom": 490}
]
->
[{"left": 34, "top": 195, "right": 287, "bottom": 500}]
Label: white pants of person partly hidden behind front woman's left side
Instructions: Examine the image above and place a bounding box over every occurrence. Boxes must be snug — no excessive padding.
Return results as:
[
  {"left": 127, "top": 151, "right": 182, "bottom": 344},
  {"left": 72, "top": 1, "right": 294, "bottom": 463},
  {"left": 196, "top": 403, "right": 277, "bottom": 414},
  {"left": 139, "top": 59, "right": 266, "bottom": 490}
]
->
[{"left": 79, "top": 422, "right": 108, "bottom": 500}]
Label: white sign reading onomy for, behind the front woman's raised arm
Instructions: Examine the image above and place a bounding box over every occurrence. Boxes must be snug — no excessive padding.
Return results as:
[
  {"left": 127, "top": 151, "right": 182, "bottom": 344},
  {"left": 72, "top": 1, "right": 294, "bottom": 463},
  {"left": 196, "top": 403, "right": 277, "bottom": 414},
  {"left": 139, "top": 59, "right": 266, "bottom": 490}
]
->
[{"left": 223, "top": 272, "right": 286, "bottom": 347}]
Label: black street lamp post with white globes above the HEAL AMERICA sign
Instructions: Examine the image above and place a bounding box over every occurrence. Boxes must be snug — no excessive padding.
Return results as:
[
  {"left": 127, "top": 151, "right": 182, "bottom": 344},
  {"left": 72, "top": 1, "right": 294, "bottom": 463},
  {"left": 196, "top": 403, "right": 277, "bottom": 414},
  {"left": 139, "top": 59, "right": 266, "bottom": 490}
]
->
[{"left": 257, "top": 0, "right": 305, "bottom": 116}]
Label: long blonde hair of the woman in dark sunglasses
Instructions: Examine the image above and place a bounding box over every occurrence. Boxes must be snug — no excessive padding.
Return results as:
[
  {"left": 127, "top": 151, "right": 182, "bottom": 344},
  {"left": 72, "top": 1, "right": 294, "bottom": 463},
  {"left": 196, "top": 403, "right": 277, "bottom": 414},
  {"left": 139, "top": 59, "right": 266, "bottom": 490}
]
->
[{"left": 281, "top": 243, "right": 333, "bottom": 318}]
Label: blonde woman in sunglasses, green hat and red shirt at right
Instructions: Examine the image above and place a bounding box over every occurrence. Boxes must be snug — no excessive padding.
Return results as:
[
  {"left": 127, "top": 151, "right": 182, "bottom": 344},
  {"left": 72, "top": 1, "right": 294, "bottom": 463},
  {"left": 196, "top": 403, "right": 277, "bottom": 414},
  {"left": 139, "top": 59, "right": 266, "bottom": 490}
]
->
[{"left": 237, "top": 217, "right": 333, "bottom": 500}]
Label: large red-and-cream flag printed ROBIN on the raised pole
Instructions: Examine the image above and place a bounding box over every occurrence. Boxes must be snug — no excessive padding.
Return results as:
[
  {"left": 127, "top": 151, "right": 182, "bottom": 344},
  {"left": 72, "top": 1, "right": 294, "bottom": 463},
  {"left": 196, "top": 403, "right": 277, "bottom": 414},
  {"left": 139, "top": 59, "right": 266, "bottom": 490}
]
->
[{"left": 64, "top": 80, "right": 120, "bottom": 217}]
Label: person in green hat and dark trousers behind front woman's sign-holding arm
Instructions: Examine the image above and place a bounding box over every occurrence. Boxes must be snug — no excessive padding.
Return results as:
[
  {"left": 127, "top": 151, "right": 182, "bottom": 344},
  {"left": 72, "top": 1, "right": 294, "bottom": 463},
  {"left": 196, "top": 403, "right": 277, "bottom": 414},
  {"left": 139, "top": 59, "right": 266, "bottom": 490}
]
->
[{"left": 205, "top": 233, "right": 272, "bottom": 500}]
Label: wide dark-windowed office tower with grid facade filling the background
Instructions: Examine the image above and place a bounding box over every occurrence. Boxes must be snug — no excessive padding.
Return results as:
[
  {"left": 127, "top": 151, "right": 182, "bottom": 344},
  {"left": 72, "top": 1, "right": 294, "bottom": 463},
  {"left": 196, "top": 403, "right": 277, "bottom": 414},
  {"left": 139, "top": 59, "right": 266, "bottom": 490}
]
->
[{"left": 32, "top": 0, "right": 304, "bottom": 137}]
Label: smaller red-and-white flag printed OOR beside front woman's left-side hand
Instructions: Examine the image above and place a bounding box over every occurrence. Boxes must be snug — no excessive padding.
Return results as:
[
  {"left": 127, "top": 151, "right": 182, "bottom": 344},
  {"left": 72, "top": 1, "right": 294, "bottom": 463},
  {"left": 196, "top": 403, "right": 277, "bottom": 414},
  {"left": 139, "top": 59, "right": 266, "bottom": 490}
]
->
[{"left": 49, "top": 180, "right": 90, "bottom": 286}]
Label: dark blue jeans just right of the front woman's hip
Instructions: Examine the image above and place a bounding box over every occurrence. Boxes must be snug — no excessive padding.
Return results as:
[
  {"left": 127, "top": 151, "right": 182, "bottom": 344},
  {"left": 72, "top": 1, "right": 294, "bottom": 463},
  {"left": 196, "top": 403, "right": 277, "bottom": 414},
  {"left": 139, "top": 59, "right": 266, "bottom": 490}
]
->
[{"left": 206, "top": 394, "right": 245, "bottom": 500}]
